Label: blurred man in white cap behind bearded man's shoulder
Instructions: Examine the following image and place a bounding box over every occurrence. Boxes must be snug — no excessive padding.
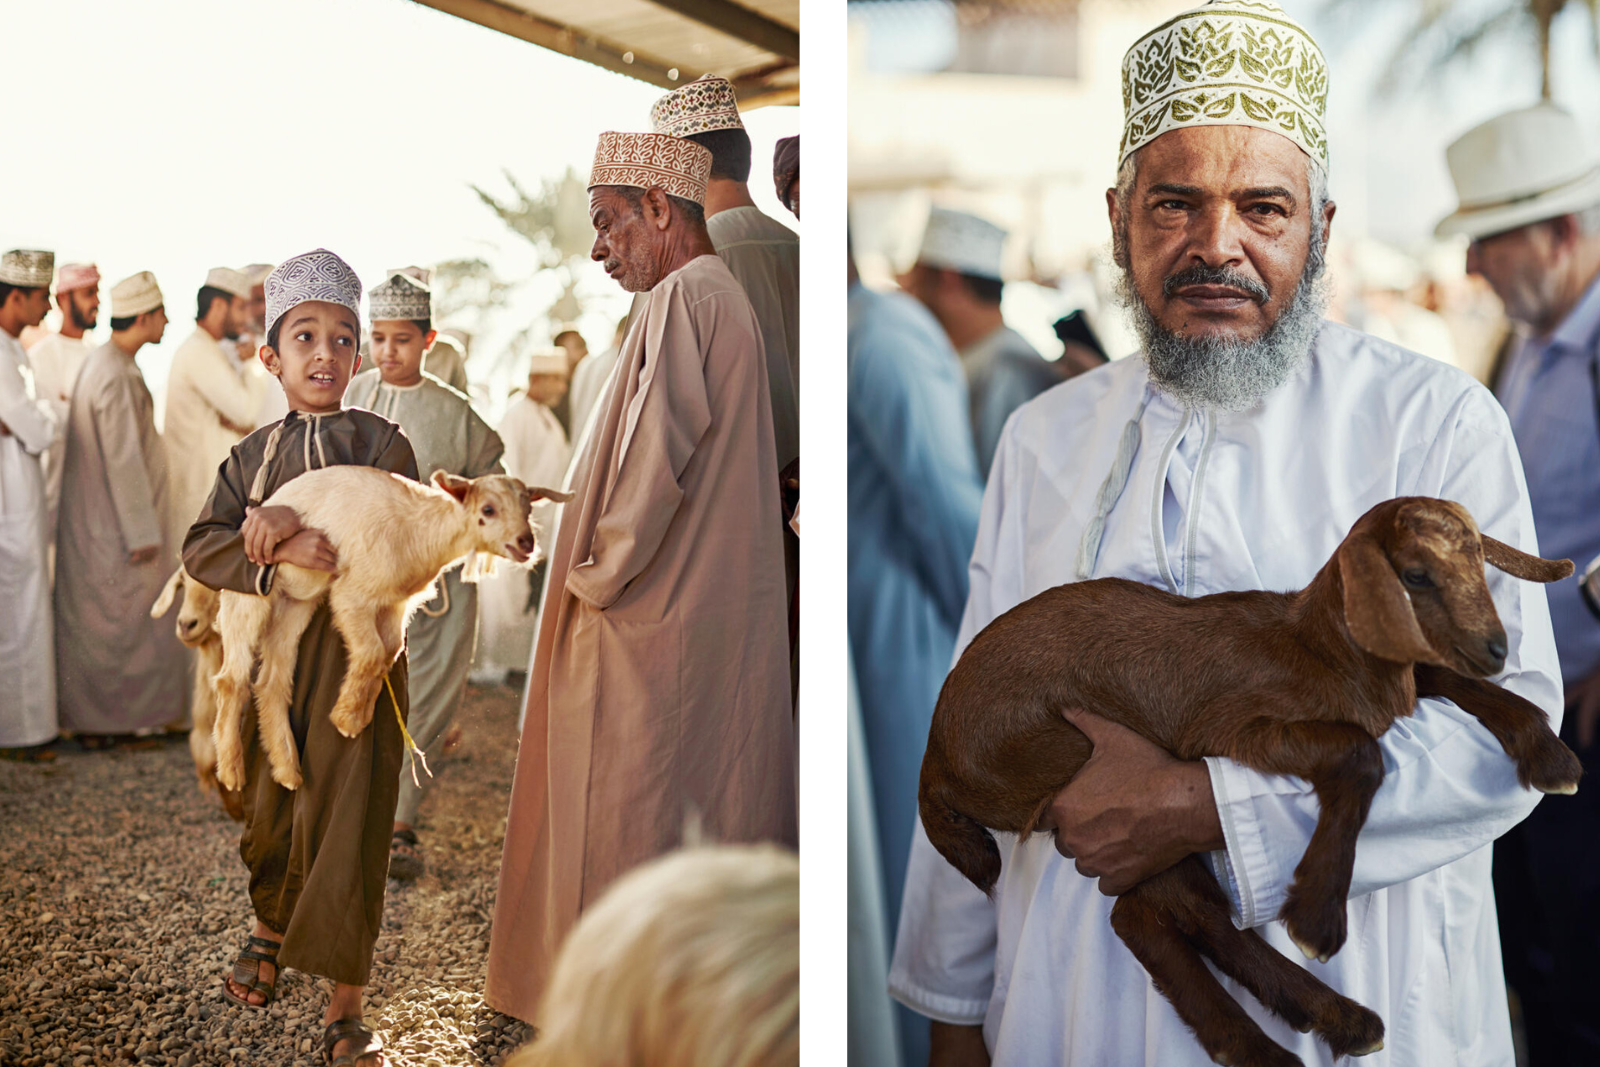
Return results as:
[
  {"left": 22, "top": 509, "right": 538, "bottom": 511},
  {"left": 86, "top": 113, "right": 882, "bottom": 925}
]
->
[{"left": 901, "top": 208, "right": 1061, "bottom": 477}]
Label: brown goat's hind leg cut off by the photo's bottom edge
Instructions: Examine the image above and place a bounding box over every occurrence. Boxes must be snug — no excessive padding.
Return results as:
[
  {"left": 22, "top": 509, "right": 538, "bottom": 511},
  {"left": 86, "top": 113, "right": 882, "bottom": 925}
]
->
[{"left": 1110, "top": 870, "right": 1304, "bottom": 1067}]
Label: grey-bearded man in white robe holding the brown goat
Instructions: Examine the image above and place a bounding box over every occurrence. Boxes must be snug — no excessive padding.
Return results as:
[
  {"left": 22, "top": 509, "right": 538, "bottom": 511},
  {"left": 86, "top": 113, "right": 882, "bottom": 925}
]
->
[{"left": 890, "top": 8, "right": 1562, "bottom": 1067}]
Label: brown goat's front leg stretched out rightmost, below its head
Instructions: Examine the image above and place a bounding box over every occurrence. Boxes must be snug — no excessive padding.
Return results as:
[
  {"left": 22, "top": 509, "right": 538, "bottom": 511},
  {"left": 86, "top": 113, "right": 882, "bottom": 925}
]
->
[{"left": 1411, "top": 664, "right": 1584, "bottom": 793}]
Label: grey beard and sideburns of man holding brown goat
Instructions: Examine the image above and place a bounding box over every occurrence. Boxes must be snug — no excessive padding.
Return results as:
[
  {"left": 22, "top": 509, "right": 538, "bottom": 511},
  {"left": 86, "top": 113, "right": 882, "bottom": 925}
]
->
[{"left": 1112, "top": 139, "right": 1328, "bottom": 411}]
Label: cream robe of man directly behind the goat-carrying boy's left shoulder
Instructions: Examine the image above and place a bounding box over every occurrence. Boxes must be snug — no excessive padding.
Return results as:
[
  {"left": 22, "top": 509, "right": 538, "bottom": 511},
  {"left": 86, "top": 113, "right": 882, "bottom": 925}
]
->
[{"left": 162, "top": 326, "right": 265, "bottom": 563}]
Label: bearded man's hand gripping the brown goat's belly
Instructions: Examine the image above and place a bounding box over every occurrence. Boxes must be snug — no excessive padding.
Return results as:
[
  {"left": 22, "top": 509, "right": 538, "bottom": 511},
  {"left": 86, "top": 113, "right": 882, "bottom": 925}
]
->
[{"left": 1046, "top": 709, "right": 1222, "bottom": 896}]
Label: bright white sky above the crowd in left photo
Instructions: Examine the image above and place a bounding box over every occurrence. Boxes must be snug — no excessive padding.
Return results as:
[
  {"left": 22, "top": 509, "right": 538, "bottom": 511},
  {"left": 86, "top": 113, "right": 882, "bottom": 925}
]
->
[{"left": 0, "top": 0, "right": 800, "bottom": 416}]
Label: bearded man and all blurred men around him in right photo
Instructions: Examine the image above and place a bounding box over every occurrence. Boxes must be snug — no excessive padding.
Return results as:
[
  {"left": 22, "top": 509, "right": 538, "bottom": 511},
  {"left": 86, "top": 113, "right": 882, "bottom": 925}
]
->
[{"left": 848, "top": 0, "right": 1600, "bottom": 1067}]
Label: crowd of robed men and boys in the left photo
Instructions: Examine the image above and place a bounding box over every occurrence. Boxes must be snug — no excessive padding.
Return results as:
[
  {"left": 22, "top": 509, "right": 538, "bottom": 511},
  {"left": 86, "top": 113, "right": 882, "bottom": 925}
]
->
[{"left": 0, "top": 75, "right": 800, "bottom": 1064}]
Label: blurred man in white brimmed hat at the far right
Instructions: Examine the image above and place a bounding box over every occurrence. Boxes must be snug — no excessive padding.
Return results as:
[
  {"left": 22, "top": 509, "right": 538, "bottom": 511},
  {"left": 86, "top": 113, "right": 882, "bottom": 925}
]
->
[{"left": 1438, "top": 104, "right": 1600, "bottom": 1067}]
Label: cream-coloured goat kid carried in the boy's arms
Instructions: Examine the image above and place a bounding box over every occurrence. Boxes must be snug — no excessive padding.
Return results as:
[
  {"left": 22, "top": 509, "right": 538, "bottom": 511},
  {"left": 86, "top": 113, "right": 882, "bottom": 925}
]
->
[{"left": 214, "top": 467, "right": 570, "bottom": 789}]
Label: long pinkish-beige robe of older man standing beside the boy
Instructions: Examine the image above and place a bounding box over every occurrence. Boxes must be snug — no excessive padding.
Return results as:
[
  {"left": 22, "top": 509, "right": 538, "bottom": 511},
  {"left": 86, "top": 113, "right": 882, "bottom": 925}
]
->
[{"left": 485, "top": 256, "right": 797, "bottom": 1021}]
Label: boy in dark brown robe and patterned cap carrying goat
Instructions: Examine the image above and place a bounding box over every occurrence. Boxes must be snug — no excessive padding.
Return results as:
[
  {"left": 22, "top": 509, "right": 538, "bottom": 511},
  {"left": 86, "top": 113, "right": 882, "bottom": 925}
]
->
[{"left": 184, "top": 250, "right": 418, "bottom": 1067}]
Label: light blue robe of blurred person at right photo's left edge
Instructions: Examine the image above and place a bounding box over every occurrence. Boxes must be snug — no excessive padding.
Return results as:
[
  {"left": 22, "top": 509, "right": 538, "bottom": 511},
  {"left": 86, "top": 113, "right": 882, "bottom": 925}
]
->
[{"left": 846, "top": 285, "right": 982, "bottom": 1062}]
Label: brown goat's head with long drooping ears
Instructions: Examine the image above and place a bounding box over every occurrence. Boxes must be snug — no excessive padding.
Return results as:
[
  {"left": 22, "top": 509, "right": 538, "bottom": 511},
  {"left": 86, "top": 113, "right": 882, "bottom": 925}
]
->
[{"left": 1338, "top": 496, "right": 1573, "bottom": 677}]
